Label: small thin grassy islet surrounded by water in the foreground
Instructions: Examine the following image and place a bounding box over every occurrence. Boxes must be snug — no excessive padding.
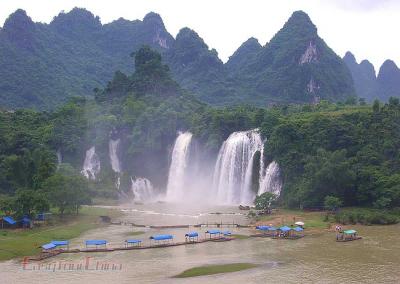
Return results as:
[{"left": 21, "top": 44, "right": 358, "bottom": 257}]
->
[{"left": 175, "top": 263, "right": 258, "bottom": 278}]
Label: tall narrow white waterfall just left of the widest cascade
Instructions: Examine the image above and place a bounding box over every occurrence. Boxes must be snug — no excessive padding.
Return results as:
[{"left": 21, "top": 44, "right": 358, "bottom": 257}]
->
[{"left": 166, "top": 132, "right": 193, "bottom": 202}]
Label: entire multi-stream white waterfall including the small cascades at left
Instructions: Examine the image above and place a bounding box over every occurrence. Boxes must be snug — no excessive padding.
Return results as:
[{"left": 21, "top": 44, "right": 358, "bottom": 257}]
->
[{"left": 82, "top": 129, "right": 282, "bottom": 205}]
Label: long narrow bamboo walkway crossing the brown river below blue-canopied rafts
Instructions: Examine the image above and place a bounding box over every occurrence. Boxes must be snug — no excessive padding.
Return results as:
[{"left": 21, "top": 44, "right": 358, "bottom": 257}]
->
[{"left": 28, "top": 237, "right": 234, "bottom": 261}]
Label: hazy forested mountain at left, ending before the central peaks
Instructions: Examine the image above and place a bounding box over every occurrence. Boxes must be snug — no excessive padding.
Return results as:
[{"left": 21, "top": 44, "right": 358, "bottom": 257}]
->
[{"left": 0, "top": 8, "right": 173, "bottom": 109}]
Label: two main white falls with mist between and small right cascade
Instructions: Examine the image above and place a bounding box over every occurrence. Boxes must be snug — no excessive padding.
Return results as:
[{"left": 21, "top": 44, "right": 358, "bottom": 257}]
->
[{"left": 165, "top": 129, "right": 282, "bottom": 205}]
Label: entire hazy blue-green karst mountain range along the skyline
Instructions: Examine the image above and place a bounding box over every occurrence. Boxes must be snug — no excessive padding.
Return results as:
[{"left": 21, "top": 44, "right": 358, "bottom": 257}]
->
[{"left": 0, "top": 8, "right": 400, "bottom": 109}]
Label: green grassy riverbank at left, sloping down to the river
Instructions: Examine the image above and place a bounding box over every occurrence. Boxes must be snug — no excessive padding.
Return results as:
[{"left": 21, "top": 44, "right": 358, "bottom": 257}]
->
[{"left": 0, "top": 207, "right": 120, "bottom": 261}]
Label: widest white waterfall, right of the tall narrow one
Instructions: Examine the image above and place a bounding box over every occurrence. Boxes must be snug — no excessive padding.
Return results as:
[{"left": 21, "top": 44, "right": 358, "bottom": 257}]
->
[{"left": 213, "top": 129, "right": 263, "bottom": 204}]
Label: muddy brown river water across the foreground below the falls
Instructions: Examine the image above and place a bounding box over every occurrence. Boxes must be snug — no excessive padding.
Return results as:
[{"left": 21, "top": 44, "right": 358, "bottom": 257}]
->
[{"left": 0, "top": 204, "right": 400, "bottom": 284}]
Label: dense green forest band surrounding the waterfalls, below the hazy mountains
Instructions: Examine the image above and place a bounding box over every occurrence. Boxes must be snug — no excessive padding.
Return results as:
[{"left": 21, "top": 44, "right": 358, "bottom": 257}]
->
[{"left": 0, "top": 47, "right": 400, "bottom": 220}]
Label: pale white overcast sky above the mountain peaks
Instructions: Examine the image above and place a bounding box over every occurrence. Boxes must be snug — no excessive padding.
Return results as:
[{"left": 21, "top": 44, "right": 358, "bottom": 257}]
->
[{"left": 0, "top": 0, "right": 400, "bottom": 69}]
